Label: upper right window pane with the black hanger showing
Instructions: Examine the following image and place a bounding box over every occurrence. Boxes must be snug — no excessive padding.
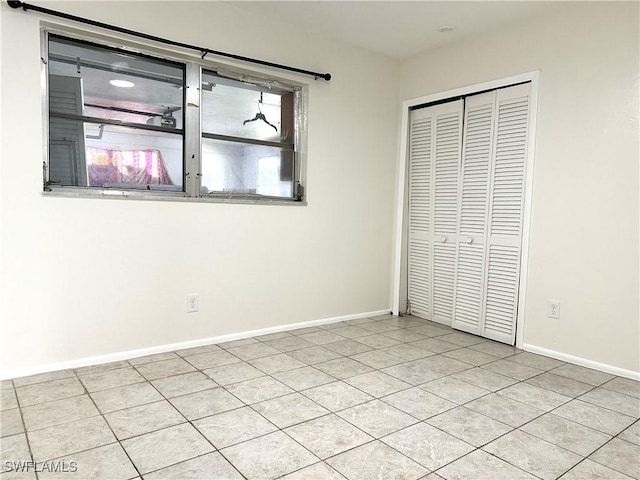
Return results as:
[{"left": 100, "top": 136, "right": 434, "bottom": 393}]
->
[{"left": 201, "top": 72, "right": 294, "bottom": 144}]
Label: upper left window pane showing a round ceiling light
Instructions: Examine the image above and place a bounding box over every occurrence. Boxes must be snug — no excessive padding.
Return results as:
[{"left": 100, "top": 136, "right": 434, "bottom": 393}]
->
[{"left": 48, "top": 36, "right": 184, "bottom": 129}]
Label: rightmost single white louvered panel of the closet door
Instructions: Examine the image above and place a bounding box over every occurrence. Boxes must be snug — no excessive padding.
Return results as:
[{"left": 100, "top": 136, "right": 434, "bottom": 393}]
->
[{"left": 480, "top": 83, "right": 530, "bottom": 344}]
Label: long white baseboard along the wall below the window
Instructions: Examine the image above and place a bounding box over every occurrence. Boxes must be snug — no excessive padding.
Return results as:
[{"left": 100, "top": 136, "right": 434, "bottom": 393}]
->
[{"left": 0, "top": 308, "right": 391, "bottom": 380}]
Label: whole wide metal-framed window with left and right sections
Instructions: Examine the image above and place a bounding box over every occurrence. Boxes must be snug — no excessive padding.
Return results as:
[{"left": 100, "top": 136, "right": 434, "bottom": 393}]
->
[{"left": 45, "top": 34, "right": 303, "bottom": 200}]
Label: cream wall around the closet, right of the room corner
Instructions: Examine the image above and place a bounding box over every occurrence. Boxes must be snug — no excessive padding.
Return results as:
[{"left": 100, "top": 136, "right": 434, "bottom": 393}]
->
[{"left": 400, "top": 2, "right": 640, "bottom": 372}]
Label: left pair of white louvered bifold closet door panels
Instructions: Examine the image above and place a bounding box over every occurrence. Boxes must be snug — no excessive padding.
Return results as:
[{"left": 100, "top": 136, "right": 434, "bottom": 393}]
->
[{"left": 408, "top": 100, "right": 463, "bottom": 325}]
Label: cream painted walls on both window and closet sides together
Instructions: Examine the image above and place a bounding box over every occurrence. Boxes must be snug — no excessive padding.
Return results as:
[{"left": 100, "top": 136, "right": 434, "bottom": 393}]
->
[{"left": 0, "top": 2, "right": 640, "bottom": 375}]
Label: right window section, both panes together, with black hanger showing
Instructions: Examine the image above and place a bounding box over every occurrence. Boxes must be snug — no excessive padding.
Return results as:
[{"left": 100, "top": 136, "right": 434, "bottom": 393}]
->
[{"left": 201, "top": 71, "right": 295, "bottom": 197}]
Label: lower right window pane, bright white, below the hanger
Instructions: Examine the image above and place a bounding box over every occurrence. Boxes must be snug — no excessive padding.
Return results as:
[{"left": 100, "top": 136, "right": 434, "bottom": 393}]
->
[{"left": 202, "top": 139, "right": 293, "bottom": 198}]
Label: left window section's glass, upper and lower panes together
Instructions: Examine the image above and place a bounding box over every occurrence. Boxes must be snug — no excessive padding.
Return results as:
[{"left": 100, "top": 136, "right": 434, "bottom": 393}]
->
[{"left": 48, "top": 35, "right": 184, "bottom": 191}]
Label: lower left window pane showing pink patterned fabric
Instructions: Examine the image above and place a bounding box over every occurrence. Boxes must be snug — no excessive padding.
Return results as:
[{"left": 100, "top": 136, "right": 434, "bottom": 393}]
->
[{"left": 49, "top": 118, "right": 183, "bottom": 192}]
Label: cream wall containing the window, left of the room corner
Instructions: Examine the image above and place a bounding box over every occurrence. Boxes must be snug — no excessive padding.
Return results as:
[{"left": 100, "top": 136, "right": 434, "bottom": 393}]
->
[{"left": 0, "top": 2, "right": 398, "bottom": 376}]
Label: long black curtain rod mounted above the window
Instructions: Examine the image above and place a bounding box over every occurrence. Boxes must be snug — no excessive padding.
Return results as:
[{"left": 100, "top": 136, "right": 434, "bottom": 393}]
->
[{"left": 7, "top": 0, "right": 331, "bottom": 82}]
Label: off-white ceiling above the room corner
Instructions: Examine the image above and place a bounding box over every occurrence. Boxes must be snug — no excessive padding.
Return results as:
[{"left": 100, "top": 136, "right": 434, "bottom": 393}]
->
[{"left": 233, "top": 1, "right": 566, "bottom": 60}]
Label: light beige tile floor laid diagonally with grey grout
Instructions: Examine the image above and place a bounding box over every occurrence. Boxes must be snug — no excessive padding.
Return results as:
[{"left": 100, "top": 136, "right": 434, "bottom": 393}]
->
[{"left": 0, "top": 315, "right": 640, "bottom": 480}]
